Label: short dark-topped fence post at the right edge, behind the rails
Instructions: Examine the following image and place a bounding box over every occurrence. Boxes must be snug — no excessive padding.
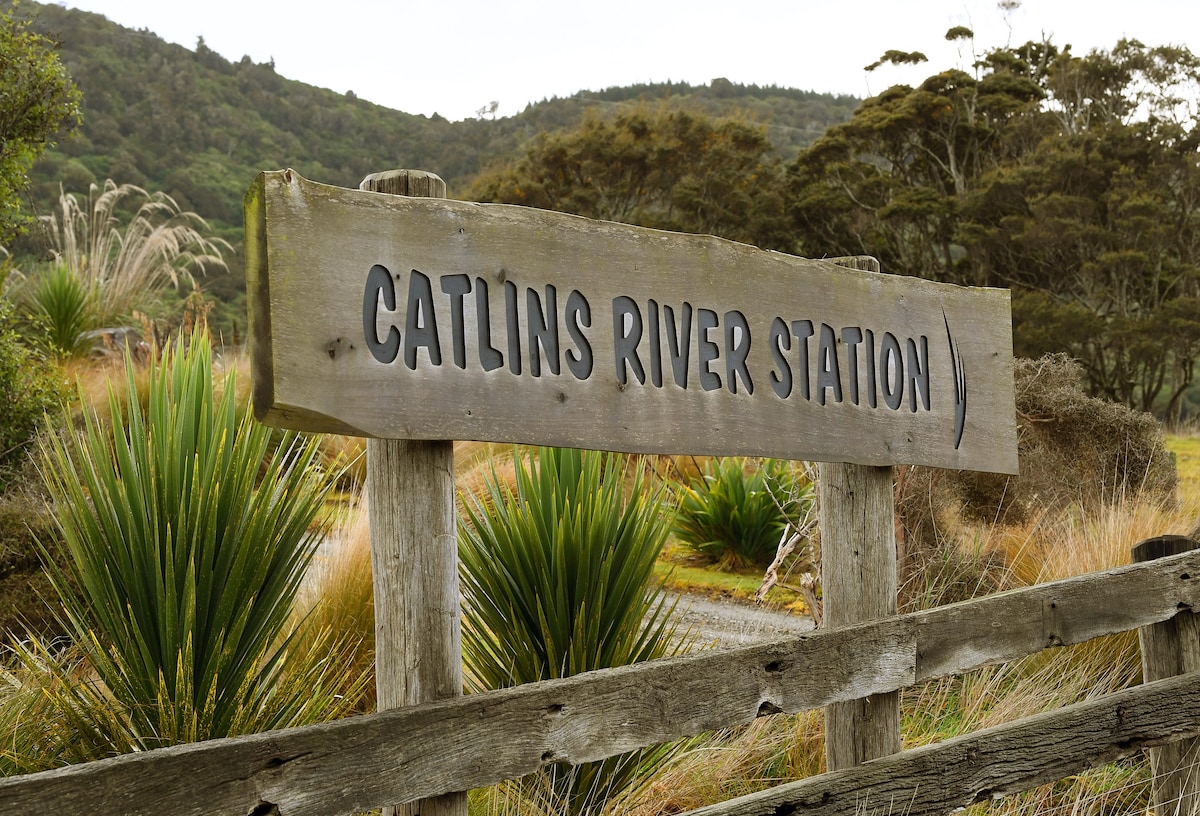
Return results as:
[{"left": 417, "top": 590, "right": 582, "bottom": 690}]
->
[{"left": 1133, "top": 535, "right": 1200, "bottom": 816}]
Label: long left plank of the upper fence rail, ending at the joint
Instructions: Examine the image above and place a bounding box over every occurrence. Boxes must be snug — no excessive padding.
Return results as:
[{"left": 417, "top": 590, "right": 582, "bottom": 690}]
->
[{"left": 0, "top": 626, "right": 916, "bottom": 816}]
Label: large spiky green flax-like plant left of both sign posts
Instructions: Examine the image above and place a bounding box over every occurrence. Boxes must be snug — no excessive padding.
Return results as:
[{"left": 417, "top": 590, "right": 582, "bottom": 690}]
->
[{"left": 0, "top": 332, "right": 362, "bottom": 769}]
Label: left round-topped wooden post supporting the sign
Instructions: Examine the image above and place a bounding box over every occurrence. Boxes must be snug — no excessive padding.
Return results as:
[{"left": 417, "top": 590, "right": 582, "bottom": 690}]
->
[{"left": 359, "top": 170, "right": 467, "bottom": 816}]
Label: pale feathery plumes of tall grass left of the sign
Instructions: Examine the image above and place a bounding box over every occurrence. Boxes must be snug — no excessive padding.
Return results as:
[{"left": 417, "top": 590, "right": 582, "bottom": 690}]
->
[{"left": 41, "top": 179, "right": 232, "bottom": 328}]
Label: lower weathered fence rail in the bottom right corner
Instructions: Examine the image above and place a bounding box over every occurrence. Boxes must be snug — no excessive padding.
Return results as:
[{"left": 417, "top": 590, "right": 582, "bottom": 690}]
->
[{"left": 686, "top": 674, "right": 1200, "bottom": 816}]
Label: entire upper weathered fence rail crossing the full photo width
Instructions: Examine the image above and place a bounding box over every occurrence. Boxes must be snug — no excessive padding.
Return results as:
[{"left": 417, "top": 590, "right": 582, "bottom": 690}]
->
[{"left": 0, "top": 552, "right": 1200, "bottom": 816}]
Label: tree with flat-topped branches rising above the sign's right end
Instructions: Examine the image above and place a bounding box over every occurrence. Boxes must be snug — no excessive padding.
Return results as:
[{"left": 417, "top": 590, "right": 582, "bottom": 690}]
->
[{"left": 790, "top": 28, "right": 1056, "bottom": 282}]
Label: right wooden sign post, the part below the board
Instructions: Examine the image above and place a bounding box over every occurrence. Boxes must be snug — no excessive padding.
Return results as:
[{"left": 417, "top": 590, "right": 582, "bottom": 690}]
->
[{"left": 817, "top": 463, "right": 900, "bottom": 770}]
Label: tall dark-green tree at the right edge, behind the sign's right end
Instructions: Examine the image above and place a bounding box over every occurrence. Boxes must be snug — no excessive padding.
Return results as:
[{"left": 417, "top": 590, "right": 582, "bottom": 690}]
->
[{"left": 956, "top": 42, "right": 1200, "bottom": 418}]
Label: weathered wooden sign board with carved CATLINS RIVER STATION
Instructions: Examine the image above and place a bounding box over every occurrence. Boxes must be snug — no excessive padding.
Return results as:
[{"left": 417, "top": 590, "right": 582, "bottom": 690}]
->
[{"left": 246, "top": 170, "right": 1016, "bottom": 473}]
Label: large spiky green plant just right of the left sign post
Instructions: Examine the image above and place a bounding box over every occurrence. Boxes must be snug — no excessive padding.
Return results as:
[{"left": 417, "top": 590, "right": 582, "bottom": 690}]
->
[{"left": 458, "top": 448, "right": 680, "bottom": 815}]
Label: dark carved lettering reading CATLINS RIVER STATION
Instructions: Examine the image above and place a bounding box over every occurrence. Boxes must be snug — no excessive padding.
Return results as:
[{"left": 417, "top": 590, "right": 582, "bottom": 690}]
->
[{"left": 362, "top": 264, "right": 949, "bottom": 412}]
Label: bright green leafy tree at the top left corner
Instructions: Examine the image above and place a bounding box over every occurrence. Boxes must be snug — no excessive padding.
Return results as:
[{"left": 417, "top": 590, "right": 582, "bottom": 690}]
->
[{"left": 0, "top": 2, "right": 80, "bottom": 244}]
